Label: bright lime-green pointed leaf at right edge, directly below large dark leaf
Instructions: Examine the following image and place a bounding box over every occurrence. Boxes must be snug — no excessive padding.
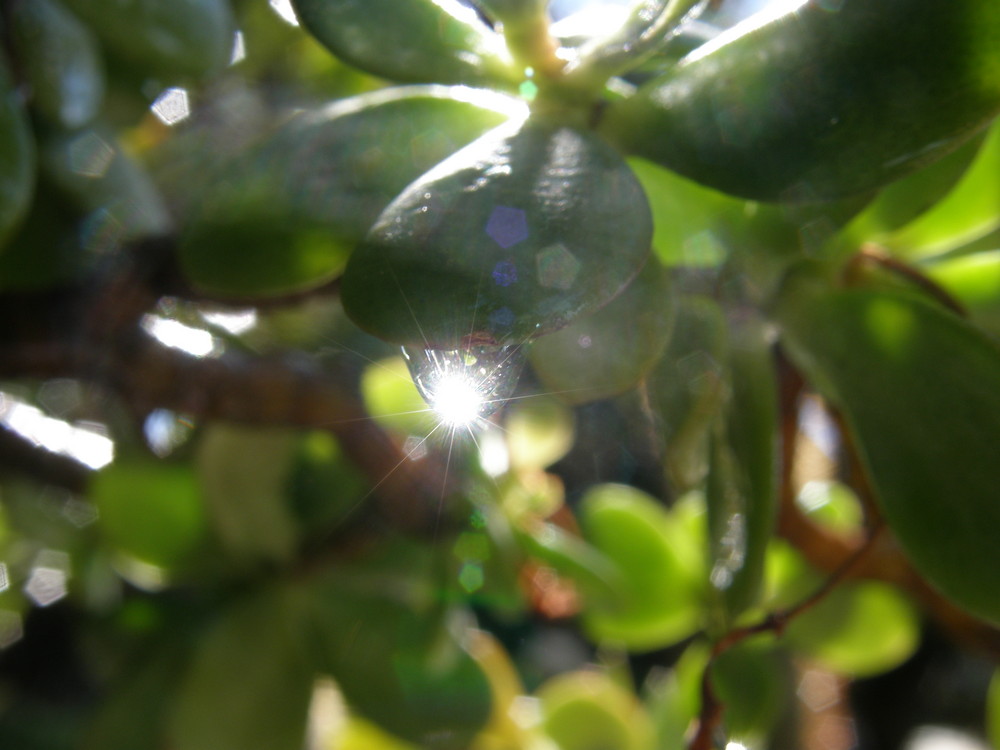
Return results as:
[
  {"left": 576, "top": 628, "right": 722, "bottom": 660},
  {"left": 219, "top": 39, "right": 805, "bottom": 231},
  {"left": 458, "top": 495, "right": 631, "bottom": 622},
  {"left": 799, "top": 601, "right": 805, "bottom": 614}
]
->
[{"left": 882, "top": 121, "right": 1000, "bottom": 258}]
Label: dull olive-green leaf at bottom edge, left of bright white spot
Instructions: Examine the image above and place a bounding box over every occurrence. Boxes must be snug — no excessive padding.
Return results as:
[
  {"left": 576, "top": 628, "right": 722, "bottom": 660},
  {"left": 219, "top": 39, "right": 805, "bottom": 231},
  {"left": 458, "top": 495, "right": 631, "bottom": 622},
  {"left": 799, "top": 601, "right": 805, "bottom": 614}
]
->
[{"left": 169, "top": 588, "right": 313, "bottom": 750}]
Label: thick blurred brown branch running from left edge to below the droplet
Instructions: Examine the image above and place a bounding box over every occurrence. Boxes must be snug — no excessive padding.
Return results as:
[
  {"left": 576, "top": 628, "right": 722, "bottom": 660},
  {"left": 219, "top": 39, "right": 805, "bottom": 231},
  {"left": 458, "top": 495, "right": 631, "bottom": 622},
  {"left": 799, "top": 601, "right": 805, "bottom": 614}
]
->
[{"left": 0, "top": 239, "right": 453, "bottom": 533}]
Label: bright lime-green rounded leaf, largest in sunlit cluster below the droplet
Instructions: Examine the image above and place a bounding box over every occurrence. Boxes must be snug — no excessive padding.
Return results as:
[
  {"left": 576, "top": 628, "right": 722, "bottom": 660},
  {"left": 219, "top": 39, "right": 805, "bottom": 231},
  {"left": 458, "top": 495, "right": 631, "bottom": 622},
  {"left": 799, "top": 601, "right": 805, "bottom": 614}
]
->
[{"left": 580, "top": 484, "right": 704, "bottom": 651}]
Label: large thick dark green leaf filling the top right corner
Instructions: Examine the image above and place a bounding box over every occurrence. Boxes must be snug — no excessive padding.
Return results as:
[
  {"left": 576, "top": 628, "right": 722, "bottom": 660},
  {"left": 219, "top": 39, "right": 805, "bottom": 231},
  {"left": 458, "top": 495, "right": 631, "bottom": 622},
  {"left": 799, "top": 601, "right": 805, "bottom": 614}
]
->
[{"left": 601, "top": 0, "right": 1000, "bottom": 202}]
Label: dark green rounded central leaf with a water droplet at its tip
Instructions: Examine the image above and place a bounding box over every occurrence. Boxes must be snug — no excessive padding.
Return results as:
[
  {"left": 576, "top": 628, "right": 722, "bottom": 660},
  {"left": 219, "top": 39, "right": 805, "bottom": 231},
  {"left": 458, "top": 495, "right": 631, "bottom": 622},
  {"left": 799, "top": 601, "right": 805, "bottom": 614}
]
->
[{"left": 342, "top": 118, "right": 652, "bottom": 349}]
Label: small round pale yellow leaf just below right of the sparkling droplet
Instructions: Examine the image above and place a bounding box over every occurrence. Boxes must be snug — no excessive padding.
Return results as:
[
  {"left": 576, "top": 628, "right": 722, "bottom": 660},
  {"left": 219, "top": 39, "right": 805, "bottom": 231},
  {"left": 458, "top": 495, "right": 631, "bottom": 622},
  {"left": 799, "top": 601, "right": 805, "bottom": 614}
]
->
[{"left": 504, "top": 396, "right": 573, "bottom": 469}]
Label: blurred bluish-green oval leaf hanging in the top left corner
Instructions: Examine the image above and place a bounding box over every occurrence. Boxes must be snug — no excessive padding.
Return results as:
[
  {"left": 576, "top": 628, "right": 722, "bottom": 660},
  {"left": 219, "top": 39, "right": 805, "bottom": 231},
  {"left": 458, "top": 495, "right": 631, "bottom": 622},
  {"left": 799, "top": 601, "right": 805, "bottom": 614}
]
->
[{"left": 9, "top": 0, "right": 104, "bottom": 128}]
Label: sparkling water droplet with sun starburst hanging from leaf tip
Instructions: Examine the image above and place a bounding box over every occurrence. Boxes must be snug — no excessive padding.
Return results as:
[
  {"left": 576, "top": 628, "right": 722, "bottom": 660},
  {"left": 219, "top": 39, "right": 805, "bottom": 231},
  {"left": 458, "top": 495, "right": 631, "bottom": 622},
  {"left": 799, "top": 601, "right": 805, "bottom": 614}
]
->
[{"left": 403, "top": 345, "right": 525, "bottom": 427}]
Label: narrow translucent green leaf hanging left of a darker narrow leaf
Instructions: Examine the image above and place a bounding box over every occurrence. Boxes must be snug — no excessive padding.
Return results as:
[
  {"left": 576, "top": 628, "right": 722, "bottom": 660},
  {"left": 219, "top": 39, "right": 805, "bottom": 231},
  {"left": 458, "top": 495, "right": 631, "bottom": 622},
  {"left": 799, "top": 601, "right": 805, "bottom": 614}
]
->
[{"left": 649, "top": 296, "right": 729, "bottom": 492}]
